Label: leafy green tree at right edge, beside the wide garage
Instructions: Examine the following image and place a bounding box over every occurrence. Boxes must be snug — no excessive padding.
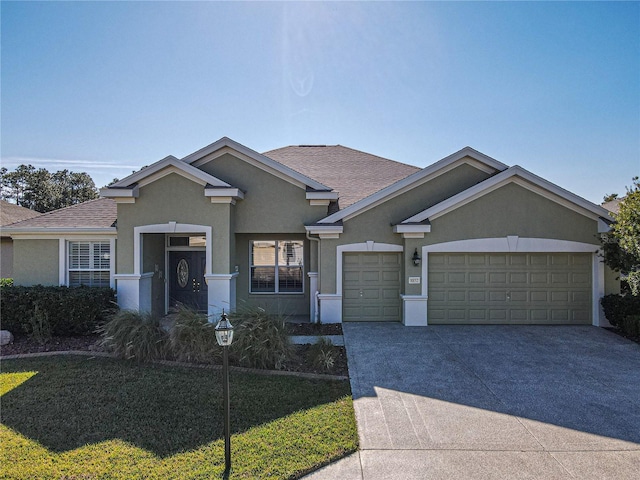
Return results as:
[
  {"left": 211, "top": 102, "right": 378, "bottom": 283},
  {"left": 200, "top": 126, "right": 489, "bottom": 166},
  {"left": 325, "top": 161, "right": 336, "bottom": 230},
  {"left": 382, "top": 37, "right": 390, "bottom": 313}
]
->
[{"left": 602, "top": 177, "right": 640, "bottom": 296}]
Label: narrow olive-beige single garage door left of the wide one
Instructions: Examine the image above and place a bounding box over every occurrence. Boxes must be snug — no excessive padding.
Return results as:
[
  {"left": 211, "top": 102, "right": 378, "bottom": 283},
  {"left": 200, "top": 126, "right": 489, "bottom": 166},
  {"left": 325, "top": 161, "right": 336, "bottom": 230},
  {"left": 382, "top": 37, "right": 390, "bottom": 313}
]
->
[{"left": 342, "top": 253, "right": 401, "bottom": 322}]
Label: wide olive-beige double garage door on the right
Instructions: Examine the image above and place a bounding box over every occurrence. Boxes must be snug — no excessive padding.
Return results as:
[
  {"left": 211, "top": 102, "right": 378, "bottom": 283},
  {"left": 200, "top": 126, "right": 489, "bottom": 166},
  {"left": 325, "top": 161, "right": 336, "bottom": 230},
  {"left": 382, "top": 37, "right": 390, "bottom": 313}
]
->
[{"left": 427, "top": 253, "right": 592, "bottom": 324}]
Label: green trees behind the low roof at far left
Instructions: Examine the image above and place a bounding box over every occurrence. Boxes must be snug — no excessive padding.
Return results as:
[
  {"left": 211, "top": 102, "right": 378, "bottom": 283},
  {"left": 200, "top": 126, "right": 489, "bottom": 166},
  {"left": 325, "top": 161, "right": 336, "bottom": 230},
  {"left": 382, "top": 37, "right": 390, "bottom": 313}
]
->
[{"left": 0, "top": 165, "right": 98, "bottom": 213}]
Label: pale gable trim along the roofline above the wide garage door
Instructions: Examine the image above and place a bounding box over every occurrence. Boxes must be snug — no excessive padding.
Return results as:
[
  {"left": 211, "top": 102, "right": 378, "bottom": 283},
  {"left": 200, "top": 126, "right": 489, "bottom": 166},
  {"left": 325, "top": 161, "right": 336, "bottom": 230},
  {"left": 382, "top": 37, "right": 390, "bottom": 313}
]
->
[{"left": 402, "top": 165, "right": 608, "bottom": 224}]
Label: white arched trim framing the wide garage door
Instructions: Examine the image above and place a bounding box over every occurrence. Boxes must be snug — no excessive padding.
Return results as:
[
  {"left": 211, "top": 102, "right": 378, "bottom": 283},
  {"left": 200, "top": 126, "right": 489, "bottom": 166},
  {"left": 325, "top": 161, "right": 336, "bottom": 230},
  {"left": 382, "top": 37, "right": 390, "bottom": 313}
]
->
[{"left": 422, "top": 235, "right": 609, "bottom": 326}]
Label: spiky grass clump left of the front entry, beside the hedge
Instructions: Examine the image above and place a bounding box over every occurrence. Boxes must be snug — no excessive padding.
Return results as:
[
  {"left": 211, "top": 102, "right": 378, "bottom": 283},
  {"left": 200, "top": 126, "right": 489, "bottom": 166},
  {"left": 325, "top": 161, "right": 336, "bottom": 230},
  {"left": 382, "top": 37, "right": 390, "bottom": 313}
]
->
[{"left": 100, "top": 310, "right": 169, "bottom": 362}]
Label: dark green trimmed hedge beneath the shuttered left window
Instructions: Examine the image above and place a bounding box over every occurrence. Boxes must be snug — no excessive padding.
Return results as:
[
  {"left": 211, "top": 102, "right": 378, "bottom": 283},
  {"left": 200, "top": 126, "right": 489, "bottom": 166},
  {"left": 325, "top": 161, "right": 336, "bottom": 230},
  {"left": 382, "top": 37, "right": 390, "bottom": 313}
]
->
[{"left": 0, "top": 285, "right": 116, "bottom": 336}]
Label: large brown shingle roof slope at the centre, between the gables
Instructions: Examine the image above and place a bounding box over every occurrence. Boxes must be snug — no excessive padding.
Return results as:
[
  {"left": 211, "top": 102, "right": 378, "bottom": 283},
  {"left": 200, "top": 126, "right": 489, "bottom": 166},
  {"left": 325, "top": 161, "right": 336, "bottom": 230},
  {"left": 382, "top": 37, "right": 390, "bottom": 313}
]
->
[{"left": 263, "top": 145, "right": 420, "bottom": 208}]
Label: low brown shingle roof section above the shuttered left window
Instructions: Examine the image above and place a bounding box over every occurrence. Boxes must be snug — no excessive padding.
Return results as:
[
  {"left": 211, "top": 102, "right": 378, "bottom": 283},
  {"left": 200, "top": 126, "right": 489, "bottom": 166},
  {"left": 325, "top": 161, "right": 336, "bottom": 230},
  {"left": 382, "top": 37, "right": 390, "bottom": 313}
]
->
[{"left": 3, "top": 198, "right": 117, "bottom": 229}]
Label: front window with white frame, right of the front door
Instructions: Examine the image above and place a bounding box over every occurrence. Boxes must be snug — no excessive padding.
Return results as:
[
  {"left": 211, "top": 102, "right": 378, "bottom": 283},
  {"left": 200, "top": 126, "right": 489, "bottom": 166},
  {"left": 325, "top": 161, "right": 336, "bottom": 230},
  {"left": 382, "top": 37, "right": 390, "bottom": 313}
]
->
[{"left": 250, "top": 240, "right": 304, "bottom": 293}]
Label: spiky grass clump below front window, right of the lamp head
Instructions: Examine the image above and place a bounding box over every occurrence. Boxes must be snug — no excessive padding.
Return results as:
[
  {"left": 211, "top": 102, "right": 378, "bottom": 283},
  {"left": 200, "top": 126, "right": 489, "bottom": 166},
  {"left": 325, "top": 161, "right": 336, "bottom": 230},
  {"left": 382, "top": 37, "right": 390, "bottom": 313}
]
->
[{"left": 230, "top": 307, "right": 294, "bottom": 370}]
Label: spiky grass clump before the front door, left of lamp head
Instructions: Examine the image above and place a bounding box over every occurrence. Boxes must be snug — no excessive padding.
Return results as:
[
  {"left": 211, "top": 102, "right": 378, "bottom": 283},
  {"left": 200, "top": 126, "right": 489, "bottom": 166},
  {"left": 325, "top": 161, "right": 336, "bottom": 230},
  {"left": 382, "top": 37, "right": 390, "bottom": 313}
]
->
[{"left": 169, "top": 306, "right": 222, "bottom": 363}]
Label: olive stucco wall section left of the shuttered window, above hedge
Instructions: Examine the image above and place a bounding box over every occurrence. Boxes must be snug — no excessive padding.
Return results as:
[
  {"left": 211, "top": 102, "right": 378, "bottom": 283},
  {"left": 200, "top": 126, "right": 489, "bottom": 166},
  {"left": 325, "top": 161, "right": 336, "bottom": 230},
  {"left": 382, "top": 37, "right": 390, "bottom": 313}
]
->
[{"left": 13, "top": 240, "right": 59, "bottom": 286}]
